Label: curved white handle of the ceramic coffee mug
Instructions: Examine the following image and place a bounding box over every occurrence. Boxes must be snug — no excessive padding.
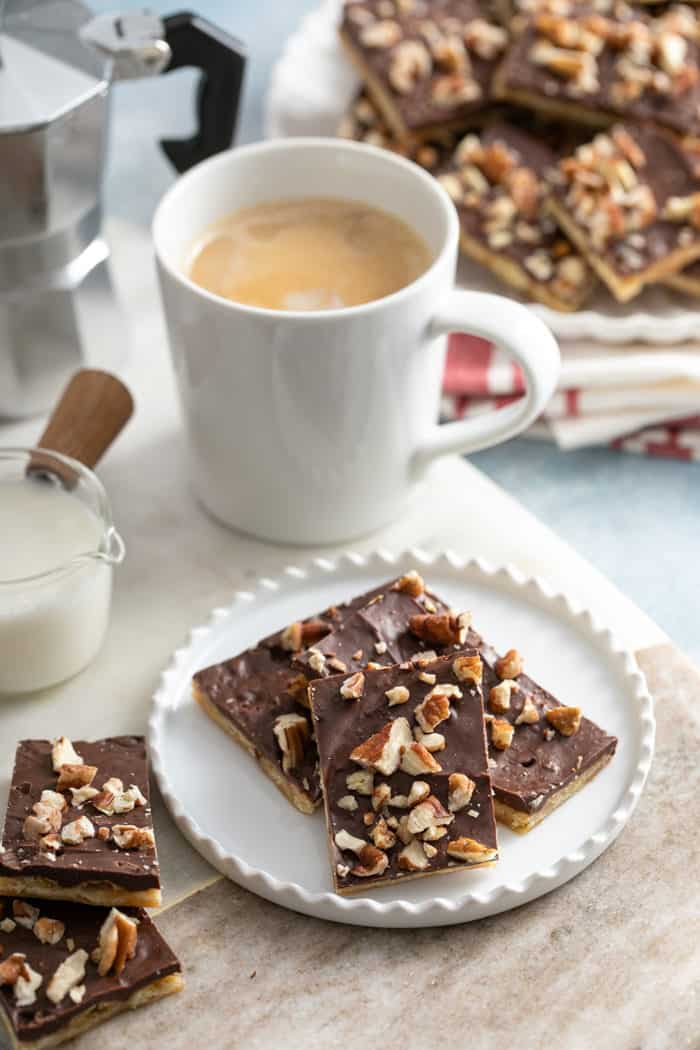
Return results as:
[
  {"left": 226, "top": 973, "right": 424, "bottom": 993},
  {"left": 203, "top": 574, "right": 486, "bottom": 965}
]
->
[{"left": 413, "top": 291, "right": 561, "bottom": 473}]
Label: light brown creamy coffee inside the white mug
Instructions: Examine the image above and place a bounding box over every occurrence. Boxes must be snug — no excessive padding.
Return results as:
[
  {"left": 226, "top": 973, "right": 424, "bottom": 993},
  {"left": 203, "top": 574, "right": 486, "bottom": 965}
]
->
[{"left": 188, "top": 197, "right": 432, "bottom": 310}]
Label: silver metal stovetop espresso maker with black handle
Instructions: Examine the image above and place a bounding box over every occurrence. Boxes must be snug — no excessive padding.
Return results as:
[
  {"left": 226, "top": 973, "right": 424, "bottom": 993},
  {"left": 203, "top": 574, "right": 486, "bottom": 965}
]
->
[{"left": 0, "top": 0, "right": 245, "bottom": 419}]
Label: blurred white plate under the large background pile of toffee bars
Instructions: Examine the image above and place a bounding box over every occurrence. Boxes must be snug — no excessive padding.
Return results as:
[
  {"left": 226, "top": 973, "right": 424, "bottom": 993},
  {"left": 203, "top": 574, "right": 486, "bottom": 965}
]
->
[{"left": 266, "top": 0, "right": 698, "bottom": 344}]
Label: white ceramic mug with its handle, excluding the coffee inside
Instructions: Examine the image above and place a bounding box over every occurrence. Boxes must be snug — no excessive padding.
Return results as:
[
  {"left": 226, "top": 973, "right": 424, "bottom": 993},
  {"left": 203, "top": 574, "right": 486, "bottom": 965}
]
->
[{"left": 153, "top": 139, "right": 559, "bottom": 544}]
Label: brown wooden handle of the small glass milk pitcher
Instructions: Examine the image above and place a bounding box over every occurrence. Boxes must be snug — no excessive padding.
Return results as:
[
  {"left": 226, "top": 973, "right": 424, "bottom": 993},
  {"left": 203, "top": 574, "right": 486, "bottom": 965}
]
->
[{"left": 38, "top": 369, "right": 133, "bottom": 467}]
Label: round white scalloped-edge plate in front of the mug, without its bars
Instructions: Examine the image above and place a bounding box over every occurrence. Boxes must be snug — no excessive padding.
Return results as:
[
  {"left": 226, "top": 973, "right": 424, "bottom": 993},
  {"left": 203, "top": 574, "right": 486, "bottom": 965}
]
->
[{"left": 149, "top": 551, "right": 654, "bottom": 927}]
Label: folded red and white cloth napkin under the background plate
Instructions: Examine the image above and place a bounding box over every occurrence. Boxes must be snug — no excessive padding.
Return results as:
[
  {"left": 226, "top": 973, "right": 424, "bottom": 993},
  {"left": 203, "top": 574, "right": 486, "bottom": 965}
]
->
[{"left": 443, "top": 335, "right": 700, "bottom": 460}]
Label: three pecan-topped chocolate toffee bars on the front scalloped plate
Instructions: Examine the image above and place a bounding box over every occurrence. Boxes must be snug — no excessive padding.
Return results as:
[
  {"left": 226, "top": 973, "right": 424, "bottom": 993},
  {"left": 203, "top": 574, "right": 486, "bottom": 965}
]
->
[{"left": 193, "top": 571, "right": 616, "bottom": 894}]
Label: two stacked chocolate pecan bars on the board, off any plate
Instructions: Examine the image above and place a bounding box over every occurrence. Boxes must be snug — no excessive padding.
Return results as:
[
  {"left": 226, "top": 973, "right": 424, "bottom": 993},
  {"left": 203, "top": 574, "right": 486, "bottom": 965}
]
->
[{"left": 0, "top": 736, "right": 183, "bottom": 1050}]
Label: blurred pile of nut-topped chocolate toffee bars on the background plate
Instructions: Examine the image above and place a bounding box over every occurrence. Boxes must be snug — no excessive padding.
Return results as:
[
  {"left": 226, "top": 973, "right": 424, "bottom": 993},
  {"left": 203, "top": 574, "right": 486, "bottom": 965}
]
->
[{"left": 339, "top": 0, "right": 700, "bottom": 311}]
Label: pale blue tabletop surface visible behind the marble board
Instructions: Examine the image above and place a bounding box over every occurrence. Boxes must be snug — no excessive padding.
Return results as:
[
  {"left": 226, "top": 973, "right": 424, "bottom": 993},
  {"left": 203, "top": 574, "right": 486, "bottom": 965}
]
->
[{"left": 99, "top": 0, "right": 700, "bottom": 663}]
